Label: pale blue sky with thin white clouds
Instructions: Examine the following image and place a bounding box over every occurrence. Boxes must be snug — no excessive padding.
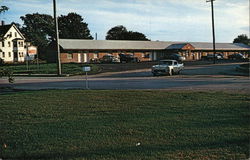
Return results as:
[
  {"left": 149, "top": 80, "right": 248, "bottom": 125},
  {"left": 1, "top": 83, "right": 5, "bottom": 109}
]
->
[{"left": 0, "top": 0, "right": 250, "bottom": 43}]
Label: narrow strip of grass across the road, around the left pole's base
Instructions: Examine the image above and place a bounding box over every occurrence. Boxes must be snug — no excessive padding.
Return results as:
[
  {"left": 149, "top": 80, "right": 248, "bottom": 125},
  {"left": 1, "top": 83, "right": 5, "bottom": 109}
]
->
[{"left": 1, "top": 63, "right": 100, "bottom": 75}]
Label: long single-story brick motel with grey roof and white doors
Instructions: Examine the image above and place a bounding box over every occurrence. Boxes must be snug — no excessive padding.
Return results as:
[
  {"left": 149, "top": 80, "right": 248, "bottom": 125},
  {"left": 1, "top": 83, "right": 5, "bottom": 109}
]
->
[{"left": 49, "top": 39, "right": 250, "bottom": 63}]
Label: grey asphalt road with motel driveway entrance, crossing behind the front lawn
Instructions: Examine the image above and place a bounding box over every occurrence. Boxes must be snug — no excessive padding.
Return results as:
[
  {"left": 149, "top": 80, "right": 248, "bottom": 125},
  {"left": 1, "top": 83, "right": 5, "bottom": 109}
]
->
[{"left": 0, "top": 64, "right": 250, "bottom": 93}]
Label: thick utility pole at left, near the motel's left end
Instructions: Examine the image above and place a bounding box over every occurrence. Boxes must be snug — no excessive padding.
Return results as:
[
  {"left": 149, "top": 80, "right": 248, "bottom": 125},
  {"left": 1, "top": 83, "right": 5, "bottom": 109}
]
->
[{"left": 53, "top": 0, "right": 62, "bottom": 76}]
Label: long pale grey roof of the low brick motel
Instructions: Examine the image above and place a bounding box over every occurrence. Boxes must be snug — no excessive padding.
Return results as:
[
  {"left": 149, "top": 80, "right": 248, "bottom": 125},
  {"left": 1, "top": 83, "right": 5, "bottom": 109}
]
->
[{"left": 59, "top": 39, "right": 250, "bottom": 51}]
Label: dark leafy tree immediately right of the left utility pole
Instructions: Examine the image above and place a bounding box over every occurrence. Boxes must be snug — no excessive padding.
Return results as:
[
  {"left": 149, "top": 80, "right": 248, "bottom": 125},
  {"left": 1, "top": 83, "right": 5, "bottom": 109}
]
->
[{"left": 58, "top": 13, "right": 93, "bottom": 39}]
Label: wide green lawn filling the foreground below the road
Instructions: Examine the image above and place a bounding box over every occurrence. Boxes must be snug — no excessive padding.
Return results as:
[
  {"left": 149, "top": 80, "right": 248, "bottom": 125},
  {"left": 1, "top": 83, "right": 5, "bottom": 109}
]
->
[{"left": 0, "top": 90, "right": 250, "bottom": 160}]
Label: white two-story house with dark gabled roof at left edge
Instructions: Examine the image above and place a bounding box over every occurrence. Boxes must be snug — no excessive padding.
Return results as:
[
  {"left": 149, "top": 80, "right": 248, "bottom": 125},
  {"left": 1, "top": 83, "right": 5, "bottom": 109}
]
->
[{"left": 0, "top": 23, "right": 27, "bottom": 63}]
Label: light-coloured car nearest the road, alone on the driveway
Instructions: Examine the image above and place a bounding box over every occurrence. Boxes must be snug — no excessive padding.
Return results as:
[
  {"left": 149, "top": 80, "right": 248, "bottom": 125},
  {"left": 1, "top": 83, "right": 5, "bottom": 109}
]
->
[{"left": 151, "top": 60, "right": 184, "bottom": 76}]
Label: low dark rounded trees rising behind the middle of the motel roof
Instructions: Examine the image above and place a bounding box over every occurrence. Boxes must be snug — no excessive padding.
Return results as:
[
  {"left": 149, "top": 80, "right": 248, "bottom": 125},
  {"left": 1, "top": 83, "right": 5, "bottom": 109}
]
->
[{"left": 106, "top": 25, "right": 149, "bottom": 41}]
